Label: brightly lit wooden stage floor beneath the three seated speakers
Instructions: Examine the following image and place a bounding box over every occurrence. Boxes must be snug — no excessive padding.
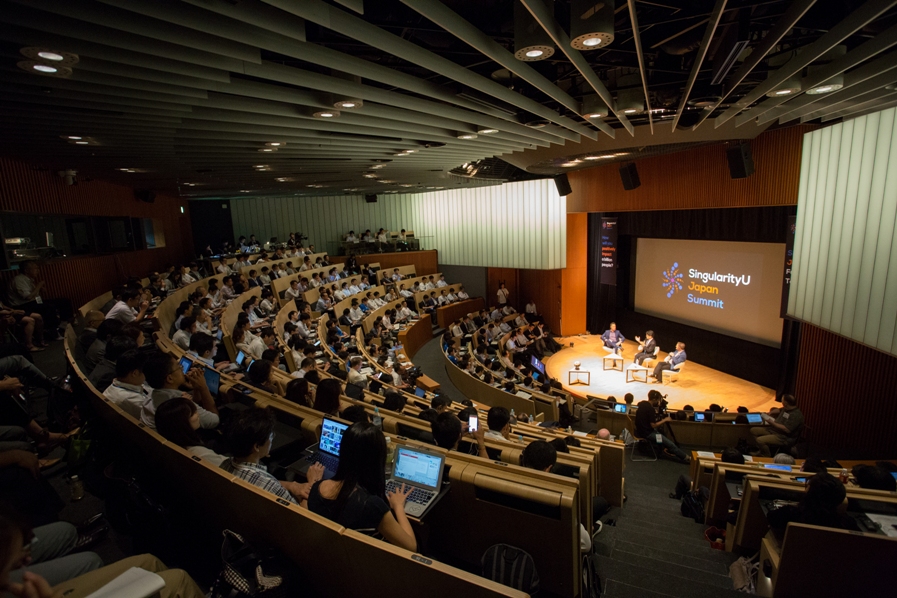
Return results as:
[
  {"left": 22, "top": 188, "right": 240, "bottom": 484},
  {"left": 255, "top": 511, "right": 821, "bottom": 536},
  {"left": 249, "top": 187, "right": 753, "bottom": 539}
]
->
[{"left": 544, "top": 335, "right": 780, "bottom": 412}]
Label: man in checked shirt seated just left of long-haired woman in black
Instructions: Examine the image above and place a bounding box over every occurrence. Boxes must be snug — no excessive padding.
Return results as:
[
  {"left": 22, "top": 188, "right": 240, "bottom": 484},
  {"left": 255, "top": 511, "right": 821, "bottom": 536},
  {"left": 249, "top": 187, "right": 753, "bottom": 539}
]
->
[{"left": 221, "top": 407, "right": 324, "bottom": 504}]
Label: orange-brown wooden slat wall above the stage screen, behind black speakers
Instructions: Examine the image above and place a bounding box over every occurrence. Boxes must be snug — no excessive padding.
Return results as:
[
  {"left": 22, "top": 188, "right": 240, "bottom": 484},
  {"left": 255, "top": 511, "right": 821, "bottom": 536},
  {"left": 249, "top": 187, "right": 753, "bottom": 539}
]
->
[{"left": 567, "top": 126, "right": 812, "bottom": 212}]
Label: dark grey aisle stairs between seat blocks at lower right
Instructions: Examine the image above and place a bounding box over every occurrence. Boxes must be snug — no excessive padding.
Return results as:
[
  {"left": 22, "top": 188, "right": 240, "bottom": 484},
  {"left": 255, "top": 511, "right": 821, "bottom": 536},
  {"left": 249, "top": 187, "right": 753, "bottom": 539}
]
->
[{"left": 595, "top": 460, "right": 744, "bottom": 598}]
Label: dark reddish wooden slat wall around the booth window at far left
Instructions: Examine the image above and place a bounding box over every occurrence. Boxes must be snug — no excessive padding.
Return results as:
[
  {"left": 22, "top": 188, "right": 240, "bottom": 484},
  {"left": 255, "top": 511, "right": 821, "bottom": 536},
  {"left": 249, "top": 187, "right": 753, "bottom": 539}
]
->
[{"left": 0, "top": 158, "right": 193, "bottom": 308}]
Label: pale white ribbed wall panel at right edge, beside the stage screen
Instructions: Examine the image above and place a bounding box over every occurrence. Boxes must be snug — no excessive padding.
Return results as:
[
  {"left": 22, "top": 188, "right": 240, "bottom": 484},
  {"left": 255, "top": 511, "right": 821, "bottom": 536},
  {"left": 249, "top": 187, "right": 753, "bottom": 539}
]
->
[{"left": 788, "top": 108, "right": 897, "bottom": 355}]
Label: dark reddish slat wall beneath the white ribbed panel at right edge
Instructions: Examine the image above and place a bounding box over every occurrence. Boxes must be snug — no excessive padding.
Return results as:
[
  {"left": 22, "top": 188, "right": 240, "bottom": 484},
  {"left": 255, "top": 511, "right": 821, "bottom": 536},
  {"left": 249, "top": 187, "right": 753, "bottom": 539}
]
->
[{"left": 794, "top": 324, "right": 897, "bottom": 459}]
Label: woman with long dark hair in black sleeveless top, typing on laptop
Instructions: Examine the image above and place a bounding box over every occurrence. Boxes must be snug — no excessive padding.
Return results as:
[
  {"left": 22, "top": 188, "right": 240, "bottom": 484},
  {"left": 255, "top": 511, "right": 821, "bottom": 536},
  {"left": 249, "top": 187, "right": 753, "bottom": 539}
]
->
[{"left": 308, "top": 421, "right": 417, "bottom": 551}]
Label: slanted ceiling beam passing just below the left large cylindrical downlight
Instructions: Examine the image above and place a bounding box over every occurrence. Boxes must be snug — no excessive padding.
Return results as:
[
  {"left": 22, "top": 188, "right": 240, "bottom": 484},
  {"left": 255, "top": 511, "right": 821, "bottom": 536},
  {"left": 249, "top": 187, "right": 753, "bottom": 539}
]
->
[{"left": 401, "top": 0, "right": 613, "bottom": 137}]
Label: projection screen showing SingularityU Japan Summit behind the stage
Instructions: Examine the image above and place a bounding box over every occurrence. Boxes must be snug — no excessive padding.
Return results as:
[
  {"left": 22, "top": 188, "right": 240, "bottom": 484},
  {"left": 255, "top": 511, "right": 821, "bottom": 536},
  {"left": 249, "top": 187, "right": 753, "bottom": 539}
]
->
[{"left": 629, "top": 238, "right": 785, "bottom": 351}]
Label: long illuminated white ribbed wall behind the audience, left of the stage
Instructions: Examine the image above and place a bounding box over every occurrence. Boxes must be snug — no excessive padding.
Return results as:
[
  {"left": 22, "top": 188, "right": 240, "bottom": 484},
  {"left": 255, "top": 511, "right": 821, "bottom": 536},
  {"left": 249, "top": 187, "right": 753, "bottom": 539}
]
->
[{"left": 231, "top": 179, "right": 567, "bottom": 270}]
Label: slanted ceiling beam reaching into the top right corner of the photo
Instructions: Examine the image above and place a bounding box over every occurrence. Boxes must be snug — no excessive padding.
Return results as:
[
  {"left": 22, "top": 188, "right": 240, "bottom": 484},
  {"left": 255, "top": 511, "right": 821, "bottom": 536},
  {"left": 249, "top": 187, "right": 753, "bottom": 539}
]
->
[{"left": 714, "top": 0, "right": 897, "bottom": 128}]
